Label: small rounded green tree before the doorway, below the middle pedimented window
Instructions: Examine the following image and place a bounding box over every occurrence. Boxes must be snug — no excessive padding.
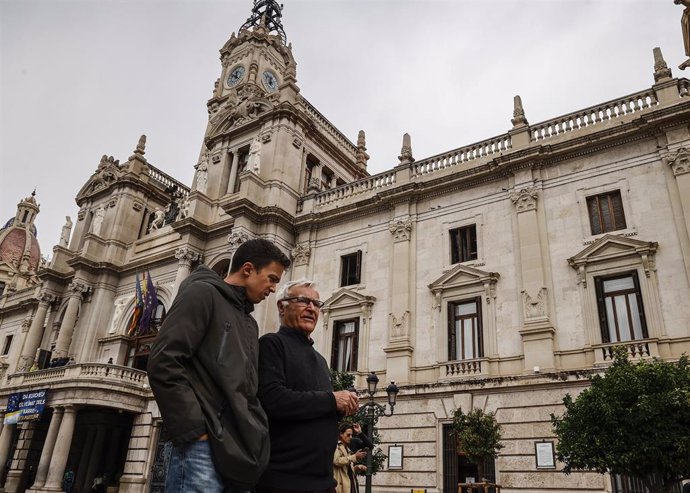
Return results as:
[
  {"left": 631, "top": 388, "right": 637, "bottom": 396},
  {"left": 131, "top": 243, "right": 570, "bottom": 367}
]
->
[{"left": 453, "top": 408, "right": 503, "bottom": 481}]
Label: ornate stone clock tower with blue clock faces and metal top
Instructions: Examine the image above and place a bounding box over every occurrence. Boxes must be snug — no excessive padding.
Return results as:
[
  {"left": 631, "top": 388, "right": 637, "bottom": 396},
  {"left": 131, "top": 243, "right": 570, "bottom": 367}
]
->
[{"left": 192, "top": 0, "right": 367, "bottom": 242}]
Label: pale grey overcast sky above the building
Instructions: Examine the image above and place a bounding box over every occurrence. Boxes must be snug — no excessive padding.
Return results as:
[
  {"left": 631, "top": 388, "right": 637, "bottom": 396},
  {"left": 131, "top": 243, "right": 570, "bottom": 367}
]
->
[{"left": 0, "top": 0, "right": 690, "bottom": 255}]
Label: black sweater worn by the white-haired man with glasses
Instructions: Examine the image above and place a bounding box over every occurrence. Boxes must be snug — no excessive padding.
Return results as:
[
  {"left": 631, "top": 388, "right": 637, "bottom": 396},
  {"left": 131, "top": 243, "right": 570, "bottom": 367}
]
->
[{"left": 259, "top": 326, "right": 338, "bottom": 491}]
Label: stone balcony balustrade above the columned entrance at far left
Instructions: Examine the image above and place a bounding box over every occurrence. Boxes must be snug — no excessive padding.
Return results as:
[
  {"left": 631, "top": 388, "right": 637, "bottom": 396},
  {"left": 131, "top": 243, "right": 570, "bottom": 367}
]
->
[{"left": 8, "top": 363, "right": 148, "bottom": 387}]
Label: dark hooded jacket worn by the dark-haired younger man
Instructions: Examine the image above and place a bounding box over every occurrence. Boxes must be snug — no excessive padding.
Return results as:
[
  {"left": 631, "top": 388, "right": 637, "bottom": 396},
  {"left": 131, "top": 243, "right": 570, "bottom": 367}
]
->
[{"left": 148, "top": 266, "right": 270, "bottom": 489}]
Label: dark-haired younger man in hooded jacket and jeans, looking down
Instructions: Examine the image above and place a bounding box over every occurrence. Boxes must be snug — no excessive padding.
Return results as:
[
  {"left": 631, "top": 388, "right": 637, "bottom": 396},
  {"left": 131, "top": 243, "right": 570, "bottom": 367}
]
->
[{"left": 148, "top": 239, "right": 290, "bottom": 493}]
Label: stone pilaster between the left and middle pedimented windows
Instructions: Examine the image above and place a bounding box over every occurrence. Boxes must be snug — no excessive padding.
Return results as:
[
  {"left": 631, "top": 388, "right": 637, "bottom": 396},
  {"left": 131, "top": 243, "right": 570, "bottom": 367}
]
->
[{"left": 382, "top": 215, "right": 414, "bottom": 384}]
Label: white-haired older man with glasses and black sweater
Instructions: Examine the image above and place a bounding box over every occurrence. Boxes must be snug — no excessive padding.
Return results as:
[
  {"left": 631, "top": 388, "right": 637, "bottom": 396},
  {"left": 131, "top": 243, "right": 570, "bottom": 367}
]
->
[{"left": 257, "top": 280, "right": 358, "bottom": 493}]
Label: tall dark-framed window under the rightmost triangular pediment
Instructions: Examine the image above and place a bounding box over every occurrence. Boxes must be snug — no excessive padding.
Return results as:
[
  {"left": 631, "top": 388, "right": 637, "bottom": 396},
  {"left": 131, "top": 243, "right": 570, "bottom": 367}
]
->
[{"left": 595, "top": 272, "right": 647, "bottom": 343}]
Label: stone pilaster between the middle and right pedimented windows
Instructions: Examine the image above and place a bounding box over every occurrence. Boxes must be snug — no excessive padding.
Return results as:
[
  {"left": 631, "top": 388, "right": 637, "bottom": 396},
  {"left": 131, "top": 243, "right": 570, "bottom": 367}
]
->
[{"left": 509, "top": 182, "right": 555, "bottom": 372}]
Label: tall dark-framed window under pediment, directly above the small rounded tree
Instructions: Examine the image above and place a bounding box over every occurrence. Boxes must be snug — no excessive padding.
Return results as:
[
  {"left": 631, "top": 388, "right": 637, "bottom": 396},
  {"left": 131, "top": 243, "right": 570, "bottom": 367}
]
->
[{"left": 448, "top": 297, "right": 484, "bottom": 361}]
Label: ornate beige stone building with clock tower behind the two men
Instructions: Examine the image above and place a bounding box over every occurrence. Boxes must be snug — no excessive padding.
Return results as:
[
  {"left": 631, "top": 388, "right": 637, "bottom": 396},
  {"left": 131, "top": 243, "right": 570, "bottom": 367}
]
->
[{"left": 0, "top": 0, "right": 690, "bottom": 493}]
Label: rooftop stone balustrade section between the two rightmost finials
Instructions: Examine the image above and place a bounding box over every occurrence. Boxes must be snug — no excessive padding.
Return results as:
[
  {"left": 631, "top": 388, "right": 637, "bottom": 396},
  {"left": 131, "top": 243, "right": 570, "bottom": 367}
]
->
[{"left": 530, "top": 89, "right": 659, "bottom": 142}]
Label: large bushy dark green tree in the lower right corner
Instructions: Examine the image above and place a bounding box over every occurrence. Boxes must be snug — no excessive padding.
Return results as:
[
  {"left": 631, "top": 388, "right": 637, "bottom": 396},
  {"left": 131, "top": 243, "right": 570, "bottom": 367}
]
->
[{"left": 551, "top": 348, "right": 690, "bottom": 493}]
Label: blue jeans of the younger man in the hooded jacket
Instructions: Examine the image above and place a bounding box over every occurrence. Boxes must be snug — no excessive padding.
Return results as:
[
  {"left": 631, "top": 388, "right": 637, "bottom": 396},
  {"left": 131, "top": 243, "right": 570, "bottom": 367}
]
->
[{"left": 165, "top": 440, "right": 251, "bottom": 493}]
